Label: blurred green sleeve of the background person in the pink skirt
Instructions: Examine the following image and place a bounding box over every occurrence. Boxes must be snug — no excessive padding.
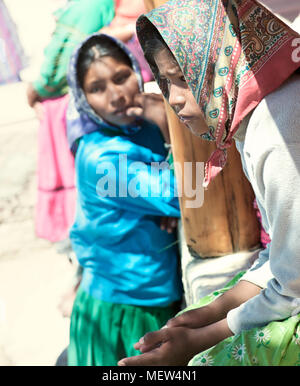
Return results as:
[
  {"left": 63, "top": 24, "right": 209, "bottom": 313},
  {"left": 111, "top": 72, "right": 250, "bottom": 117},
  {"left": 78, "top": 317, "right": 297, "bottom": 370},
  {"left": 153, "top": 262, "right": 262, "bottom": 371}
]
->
[{"left": 33, "top": 0, "right": 115, "bottom": 98}]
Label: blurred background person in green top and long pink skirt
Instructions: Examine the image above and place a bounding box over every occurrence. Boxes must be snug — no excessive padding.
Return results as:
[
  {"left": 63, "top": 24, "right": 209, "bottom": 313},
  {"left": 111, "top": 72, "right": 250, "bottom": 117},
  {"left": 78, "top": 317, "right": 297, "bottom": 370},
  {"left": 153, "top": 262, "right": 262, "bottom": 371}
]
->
[{"left": 27, "top": 0, "right": 115, "bottom": 247}]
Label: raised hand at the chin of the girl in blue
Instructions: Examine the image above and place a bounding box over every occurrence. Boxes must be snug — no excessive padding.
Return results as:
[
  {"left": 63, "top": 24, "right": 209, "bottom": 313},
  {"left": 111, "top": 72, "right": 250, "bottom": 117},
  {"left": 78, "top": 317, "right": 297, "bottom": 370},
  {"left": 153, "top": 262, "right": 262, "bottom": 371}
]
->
[{"left": 127, "top": 93, "right": 170, "bottom": 143}]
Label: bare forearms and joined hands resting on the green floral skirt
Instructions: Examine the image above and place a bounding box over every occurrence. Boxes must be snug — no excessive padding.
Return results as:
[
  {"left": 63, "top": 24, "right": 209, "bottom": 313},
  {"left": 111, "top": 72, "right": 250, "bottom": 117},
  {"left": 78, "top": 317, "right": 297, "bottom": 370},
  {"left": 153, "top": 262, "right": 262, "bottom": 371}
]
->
[{"left": 119, "top": 281, "right": 261, "bottom": 366}]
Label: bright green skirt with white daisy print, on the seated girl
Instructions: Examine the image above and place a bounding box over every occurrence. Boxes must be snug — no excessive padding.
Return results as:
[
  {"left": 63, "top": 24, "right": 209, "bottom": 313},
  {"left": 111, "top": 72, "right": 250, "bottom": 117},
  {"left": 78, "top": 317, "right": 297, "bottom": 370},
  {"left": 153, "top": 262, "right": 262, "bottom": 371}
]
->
[{"left": 183, "top": 272, "right": 300, "bottom": 366}]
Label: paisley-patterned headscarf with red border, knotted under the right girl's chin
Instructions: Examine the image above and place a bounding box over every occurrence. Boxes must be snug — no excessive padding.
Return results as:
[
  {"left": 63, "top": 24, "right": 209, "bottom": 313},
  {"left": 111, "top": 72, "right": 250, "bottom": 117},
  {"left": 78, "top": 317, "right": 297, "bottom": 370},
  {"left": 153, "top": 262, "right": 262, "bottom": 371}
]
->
[{"left": 137, "top": 0, "right": 300, "bottom": 187}]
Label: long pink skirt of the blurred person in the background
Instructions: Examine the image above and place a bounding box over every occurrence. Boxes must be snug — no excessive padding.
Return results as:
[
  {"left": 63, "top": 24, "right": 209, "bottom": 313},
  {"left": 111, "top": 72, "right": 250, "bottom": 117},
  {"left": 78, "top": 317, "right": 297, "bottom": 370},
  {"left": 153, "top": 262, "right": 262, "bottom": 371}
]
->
[{"left": 35, "top": 95, "right": 76, "bottom": 242}]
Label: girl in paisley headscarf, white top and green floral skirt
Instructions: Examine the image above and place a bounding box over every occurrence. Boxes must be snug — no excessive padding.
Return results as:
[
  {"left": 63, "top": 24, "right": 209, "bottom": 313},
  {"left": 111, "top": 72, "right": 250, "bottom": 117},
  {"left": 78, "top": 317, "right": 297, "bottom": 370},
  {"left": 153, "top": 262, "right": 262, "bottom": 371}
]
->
[{"left": 119, "top": 0, "right": 300, "bottom": 366}]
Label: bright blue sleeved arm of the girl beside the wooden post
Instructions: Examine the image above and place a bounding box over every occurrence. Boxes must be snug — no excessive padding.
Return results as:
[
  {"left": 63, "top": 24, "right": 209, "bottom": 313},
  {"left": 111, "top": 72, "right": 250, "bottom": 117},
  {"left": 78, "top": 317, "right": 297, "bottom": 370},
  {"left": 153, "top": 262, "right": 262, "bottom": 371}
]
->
[{"left": 83, "top": 145, "right": 180, "bottom": 218}]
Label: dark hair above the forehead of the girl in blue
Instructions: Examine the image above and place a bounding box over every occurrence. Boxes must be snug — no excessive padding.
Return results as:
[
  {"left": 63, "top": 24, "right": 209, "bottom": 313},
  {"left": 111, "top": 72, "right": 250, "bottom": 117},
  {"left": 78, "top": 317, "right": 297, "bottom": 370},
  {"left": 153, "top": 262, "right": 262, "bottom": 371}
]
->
[{"left": 76, "top": 35, "right": 132, "bottom": 88}]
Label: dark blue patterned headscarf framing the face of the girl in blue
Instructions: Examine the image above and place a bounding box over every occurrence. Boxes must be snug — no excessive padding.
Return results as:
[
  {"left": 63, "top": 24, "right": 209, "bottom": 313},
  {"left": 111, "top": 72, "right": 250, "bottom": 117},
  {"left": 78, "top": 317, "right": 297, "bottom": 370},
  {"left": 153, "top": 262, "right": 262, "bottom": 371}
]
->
[{"left": 67, "top": 34, "right": 144, "bottom": 153}]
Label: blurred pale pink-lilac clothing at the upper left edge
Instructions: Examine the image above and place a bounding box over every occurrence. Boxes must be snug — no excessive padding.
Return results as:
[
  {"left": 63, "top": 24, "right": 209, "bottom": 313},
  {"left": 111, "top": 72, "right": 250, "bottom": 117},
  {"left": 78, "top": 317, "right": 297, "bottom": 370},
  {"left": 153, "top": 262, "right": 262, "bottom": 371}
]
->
[{"left": 0, "top": 0, "right": 27, "bottom": 85}]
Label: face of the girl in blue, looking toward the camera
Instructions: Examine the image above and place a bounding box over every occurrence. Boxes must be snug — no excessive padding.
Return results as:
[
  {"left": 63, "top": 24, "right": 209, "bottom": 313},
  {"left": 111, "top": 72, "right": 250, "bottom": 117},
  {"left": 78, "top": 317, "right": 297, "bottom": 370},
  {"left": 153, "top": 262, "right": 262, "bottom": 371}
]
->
[{"left": 83, "top": 56, "right": 140, "bottom": 126}]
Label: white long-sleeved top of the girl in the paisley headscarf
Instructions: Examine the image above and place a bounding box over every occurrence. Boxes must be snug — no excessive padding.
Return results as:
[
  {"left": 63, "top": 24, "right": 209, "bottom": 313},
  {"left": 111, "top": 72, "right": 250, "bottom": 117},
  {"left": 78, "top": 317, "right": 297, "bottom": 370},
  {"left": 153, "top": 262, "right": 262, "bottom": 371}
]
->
[{"left": 227, "top": 75, "right": 300, "bottom": 334}]
